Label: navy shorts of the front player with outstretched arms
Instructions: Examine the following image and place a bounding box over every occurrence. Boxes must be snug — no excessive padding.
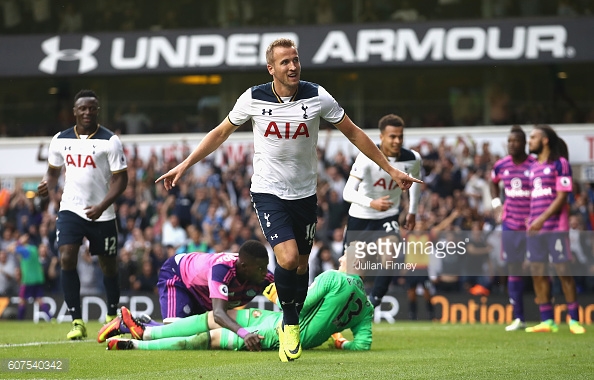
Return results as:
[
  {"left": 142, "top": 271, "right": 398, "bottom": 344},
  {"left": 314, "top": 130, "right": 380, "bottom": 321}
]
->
[{"left": 251, "top": 193, "right": 318, "bottom": 255}]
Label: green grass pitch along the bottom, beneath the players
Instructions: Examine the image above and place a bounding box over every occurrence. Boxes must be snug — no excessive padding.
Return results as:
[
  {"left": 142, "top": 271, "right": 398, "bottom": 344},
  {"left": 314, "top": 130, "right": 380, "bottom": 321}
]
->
[{"left": 0, "top": 321, "right": 594, "bottom": 380}]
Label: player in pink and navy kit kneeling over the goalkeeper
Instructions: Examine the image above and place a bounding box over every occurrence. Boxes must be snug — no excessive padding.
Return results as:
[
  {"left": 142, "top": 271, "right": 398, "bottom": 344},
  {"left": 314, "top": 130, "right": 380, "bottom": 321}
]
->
[{"left": 97, "top": 240, "right": 274, "bottom": 349}]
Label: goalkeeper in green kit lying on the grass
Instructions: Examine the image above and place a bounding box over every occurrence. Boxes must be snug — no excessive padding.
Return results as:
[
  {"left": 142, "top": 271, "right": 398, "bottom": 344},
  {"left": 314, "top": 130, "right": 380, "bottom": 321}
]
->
[{"left": 102, "top": 250, "right": 373, "bottom": 361}]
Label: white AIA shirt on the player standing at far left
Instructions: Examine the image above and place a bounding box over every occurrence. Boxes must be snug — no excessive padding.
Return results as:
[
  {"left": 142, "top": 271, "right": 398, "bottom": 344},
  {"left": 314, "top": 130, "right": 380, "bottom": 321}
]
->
[{"left": 47, "top": 126, "right": 128, "bottom": 221}]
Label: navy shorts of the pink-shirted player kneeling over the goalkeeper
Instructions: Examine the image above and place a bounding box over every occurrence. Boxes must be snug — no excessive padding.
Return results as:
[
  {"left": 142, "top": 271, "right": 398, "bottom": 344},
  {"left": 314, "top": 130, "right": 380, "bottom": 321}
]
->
[{"left": 157, "top": 254, "right": 209, "bottom": 319}]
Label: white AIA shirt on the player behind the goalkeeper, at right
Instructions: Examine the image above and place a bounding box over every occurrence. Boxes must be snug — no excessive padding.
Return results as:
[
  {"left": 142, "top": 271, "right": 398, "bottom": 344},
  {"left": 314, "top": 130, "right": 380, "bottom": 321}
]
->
[{"left": 343, "top": 148, "right": 421, "bottom": 219}]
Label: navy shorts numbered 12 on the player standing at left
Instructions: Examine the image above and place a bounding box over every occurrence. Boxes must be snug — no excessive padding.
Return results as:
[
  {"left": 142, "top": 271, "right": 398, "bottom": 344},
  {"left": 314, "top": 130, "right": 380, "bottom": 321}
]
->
[{"left": 56, "top": 211, "right": 118, "bottom": 256}]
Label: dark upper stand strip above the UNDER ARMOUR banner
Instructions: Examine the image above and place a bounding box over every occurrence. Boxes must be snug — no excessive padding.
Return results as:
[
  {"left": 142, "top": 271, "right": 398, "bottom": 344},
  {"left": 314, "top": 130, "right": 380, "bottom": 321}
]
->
[{"left": 0, "top": 0, "right": 594, "bottom": 34}]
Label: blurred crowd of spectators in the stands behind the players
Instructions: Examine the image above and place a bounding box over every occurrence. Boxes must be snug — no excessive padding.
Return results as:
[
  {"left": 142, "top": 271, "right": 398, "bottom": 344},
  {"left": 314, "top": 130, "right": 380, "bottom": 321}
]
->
[{"left": 0, "top": 130, "right": 594, "bottom": 302}]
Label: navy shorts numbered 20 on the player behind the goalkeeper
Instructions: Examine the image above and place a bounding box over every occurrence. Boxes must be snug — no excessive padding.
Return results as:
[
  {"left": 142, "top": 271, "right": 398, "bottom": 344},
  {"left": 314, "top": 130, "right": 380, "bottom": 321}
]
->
[{"left": 343, "top": 214, "right": 400, "bottom": 247}]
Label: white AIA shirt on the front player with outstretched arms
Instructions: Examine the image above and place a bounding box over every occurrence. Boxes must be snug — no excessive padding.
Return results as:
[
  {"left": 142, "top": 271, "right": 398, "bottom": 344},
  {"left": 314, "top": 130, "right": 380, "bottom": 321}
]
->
[{"left": 228, "top": 81, "right": 345, "bottom": 200}]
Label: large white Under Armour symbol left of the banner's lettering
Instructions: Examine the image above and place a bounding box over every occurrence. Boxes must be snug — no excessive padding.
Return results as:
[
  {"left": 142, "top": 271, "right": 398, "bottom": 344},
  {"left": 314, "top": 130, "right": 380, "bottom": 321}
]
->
[{"left": 39, "top": 36, "right": 101, "bottom": 74}]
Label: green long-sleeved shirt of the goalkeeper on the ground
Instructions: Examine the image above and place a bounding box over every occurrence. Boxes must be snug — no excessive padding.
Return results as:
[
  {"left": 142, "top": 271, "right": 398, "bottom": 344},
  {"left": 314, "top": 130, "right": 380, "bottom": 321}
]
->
[{"left": 299, "top": 270, "right": 373, "bottom": 350}]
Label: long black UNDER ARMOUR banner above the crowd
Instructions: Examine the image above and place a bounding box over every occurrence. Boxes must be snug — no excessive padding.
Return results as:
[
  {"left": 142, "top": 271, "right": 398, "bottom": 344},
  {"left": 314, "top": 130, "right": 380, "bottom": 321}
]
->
[{"left": 0, "top": 18, "right": 594, "bottom": 77}]
